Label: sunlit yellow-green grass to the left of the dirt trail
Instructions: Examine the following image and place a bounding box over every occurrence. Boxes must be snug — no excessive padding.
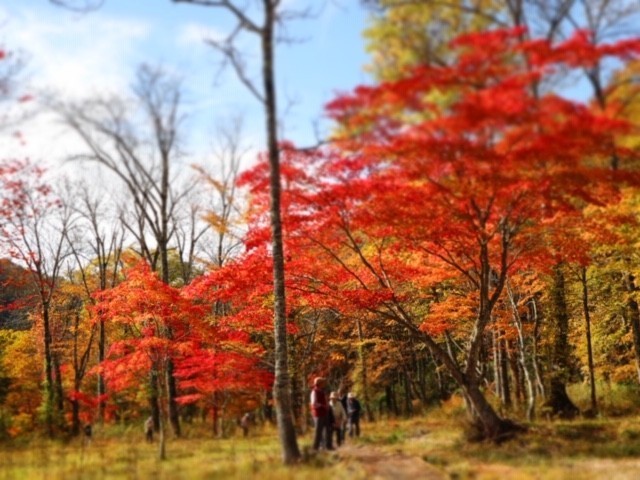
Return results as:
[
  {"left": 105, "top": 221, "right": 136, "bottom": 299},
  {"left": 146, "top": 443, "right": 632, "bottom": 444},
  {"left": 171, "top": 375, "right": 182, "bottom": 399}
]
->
[{"left": 0, "top": 427, "right": 364, "bottom": 479}]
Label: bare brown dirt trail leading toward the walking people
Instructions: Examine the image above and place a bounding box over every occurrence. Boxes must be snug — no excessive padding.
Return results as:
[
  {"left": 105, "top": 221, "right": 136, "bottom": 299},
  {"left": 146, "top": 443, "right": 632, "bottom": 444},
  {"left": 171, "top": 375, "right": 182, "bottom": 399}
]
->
[{"left": 336, "top": 444, "right": 449, "bottom": 480}]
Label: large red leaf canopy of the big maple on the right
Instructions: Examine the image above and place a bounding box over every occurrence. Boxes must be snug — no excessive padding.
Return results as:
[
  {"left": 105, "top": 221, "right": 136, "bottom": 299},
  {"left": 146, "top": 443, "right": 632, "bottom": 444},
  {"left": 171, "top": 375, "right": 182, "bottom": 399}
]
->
[{"left": 230, "top": 29, "right": 640, "bottom": 342}]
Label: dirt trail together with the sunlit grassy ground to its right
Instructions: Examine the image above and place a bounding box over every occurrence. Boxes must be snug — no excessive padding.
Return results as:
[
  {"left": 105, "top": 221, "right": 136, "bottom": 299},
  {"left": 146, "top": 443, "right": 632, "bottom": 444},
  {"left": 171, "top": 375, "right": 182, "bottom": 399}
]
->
[{"left": 324, "top": 417, "right": 640, "bottom": 480}]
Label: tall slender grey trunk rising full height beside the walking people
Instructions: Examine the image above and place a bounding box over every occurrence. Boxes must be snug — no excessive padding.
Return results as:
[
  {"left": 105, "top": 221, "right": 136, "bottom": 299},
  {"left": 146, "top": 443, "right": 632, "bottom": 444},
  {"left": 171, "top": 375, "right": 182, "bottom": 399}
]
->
[{"left": 262, "top": 0, "right": 300, "bottom": 464}]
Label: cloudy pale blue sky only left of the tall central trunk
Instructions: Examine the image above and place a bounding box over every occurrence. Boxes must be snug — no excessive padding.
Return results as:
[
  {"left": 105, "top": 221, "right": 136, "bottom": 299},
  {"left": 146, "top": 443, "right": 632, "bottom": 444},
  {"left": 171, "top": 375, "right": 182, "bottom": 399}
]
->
[{"left": 0, "top": 0, "right": 264, "bottom": 174}]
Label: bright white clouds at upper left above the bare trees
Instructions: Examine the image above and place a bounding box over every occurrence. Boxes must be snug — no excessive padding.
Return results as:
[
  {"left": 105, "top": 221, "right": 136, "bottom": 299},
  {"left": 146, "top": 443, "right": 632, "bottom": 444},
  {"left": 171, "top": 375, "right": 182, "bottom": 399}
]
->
[{"left": 0, "top": 6, "right": 151, "bottom": 167}]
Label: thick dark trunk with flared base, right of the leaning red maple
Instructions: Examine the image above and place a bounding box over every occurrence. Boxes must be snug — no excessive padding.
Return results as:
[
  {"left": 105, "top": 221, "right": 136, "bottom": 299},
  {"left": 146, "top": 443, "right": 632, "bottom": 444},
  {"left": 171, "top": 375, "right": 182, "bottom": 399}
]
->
[{"left": 546, "top": 264, "right": 579, "bottom": 418}]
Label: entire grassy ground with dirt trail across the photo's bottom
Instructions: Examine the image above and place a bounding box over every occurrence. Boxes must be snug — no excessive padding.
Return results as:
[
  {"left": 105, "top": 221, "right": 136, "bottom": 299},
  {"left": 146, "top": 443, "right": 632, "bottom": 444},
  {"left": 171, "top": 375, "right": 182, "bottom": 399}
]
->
[{"left": 0, "top": 414, "right": 640, "bottom": 480}]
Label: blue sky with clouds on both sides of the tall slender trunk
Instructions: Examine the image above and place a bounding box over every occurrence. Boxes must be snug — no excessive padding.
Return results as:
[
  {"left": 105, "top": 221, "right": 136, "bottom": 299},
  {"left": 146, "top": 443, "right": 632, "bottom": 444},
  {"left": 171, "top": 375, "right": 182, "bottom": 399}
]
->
[{"left": 0, "top": 0, "right": 368, "bottom": 169}]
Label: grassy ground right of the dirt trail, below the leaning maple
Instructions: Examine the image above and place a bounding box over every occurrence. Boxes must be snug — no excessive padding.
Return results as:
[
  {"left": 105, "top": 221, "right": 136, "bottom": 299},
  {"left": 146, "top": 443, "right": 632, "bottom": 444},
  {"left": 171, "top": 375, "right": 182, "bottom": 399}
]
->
[{"left": 368, "top": 418, "right": 640, "bottom": 480}]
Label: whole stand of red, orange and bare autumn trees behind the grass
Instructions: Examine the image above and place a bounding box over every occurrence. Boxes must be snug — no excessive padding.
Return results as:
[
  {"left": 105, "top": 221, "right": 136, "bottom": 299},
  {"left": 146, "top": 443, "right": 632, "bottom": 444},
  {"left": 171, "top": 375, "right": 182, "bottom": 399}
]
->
[{"left": 0, "top": 0, "right": 640, "bottom": 476}]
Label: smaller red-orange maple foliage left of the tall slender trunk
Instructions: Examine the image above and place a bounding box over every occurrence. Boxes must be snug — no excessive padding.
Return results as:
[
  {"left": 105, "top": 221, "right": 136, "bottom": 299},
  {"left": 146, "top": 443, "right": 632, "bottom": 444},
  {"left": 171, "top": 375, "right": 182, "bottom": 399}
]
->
[{"left": 93, "top": 262, "right": 271, "bottom": 403}]
